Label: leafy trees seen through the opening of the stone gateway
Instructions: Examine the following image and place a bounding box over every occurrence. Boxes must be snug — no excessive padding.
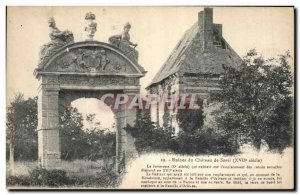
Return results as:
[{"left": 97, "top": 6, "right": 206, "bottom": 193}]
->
[{"left": 60, "top": 107, "right": 116, "bottom": 160}]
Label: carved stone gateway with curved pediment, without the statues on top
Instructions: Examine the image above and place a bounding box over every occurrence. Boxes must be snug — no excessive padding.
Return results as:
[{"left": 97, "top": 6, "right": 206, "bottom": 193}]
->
[{"left": 34, "top": 41, "right": 145, "bottom": 172}]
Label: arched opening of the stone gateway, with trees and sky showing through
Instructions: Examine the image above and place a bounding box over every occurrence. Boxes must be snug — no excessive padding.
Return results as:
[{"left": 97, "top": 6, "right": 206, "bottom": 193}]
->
[{"left": 60, "top": 97, "right": 116, "bottom": 176}]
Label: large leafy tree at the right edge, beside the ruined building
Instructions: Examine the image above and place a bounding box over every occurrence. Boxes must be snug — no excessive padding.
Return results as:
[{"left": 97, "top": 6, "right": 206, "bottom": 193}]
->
[{"left": 212, "top": 50, "right": 293, "bottom": 149}]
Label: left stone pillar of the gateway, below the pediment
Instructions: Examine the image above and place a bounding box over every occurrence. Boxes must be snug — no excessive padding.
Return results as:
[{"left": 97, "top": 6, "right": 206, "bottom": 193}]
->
[{"left": 37, "top": 77, "right": 61, "bottom": 169}]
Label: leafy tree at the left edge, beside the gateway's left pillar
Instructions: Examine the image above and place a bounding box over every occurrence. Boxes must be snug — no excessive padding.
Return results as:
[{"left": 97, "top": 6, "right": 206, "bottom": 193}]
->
[{"left": 6, "top": 93, "right": 37, "bottom": 174}]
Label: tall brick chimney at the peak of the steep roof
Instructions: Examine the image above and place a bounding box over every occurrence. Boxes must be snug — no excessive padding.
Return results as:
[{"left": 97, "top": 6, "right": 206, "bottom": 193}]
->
[{"left": 198, "top": 7, "right": 213, "bottom": 50}]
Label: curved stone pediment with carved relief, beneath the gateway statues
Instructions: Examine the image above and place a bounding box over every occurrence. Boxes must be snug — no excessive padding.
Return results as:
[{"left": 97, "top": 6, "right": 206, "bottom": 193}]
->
[{"left": 35, "top": 41, "right": 146, "bottom": 77}]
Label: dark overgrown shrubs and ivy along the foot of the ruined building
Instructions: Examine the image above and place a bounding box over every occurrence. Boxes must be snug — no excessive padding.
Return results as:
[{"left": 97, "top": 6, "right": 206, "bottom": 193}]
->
[{"left": 126, "top": 105, "right": 235, "bottom": 154}]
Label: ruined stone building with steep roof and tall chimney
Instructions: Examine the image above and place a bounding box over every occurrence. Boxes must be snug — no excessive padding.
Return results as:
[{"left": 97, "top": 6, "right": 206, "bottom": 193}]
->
[{"left": 146, "top": 8, "right": 241, "bottom": 132}]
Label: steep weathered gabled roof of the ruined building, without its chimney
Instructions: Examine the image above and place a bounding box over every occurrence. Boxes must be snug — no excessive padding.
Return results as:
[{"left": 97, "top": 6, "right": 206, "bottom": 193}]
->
[{"left": 147, "top": 10, "right": 241, "bottom": 88}]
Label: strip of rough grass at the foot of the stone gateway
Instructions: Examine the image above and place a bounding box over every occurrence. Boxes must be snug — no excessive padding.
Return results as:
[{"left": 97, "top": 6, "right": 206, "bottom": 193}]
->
[{"left": 6, "top": 160, "right": 120, "bottom": 188}]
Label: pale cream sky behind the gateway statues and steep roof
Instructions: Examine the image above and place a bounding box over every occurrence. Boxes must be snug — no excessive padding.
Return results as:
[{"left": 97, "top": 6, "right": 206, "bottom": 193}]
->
[{"left": 6, "top": 7, "right": 294, "bottom": 129}]
